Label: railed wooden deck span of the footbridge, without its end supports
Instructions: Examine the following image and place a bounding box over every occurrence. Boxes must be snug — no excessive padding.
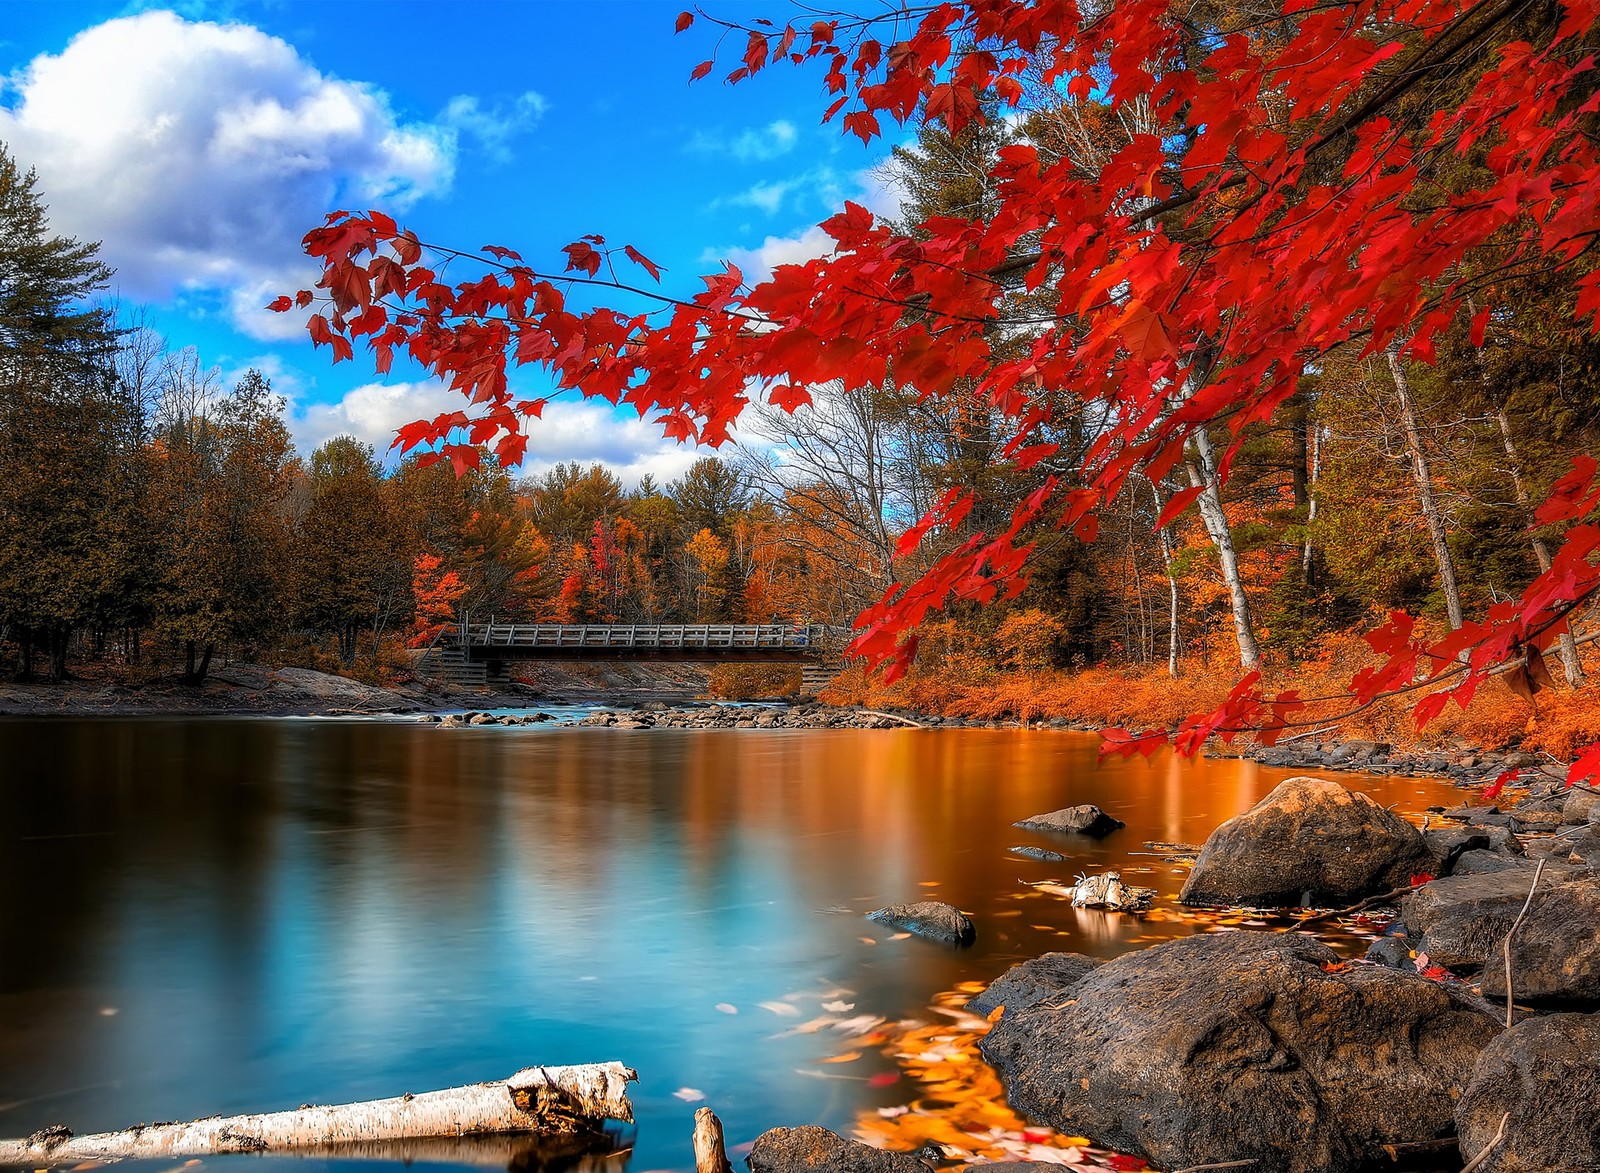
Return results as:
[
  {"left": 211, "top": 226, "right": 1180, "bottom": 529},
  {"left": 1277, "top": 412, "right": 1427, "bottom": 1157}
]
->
[{"left": 454, "top": 623, "right": 848, "bottom": 661}]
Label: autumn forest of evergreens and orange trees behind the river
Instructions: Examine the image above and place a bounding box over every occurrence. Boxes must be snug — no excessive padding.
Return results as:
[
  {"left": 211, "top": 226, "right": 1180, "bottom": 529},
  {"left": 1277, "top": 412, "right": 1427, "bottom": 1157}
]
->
[{"left": 0, "top": 64, "right": 1600, "bottom": 751}]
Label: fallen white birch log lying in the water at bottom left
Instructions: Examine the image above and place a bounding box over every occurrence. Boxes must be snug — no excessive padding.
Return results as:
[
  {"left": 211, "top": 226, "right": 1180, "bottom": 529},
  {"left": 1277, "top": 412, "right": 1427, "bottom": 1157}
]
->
[{"left": 0, "top": 1063, "right": 638, "bottom": 1165}]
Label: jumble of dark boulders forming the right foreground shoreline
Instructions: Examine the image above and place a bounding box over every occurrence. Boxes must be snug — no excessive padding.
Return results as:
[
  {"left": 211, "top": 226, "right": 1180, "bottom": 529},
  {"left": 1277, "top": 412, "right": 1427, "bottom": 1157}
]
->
[{"left": 749, "top": 778, "right": 1600, "bottom": 1173}]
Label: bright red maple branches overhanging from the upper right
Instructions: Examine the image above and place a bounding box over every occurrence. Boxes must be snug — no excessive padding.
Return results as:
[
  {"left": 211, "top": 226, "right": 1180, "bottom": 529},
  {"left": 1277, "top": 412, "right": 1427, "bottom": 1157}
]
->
[{"left": 274, "top": 0, "right": 1600, "bottom": 776}]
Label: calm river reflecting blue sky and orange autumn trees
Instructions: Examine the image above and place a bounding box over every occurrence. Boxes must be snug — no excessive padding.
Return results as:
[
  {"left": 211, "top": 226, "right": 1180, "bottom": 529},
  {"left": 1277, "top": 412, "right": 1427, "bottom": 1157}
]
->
[{"left": 0, "top": 719, "right": 1458, "bottom": 1173}]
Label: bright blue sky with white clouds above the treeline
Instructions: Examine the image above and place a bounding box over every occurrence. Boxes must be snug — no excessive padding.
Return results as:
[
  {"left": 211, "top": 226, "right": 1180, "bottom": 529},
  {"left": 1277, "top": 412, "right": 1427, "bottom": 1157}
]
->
[{"left": 0, "top": 0, "right": 891, "bottom": 480}]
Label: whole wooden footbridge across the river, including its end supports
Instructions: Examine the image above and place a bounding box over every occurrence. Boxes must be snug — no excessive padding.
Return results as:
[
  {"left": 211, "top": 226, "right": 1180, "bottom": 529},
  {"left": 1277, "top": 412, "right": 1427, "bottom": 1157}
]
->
[{"left": 418, "top": 616, "right": 851, "bottom": 688}]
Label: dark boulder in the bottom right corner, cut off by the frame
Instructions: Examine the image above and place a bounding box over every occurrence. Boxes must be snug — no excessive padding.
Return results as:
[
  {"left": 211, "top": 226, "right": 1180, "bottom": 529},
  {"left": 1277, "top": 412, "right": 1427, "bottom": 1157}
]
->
[{"left": 1456, "top": 1015, "right": 1600, "bottom": 1173}]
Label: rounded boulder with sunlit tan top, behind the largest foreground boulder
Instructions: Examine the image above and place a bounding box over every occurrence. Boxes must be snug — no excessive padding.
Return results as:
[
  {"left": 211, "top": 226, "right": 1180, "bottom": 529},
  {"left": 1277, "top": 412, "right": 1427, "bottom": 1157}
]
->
[{"left": 1179, "top": 778, "right": 1434, "bottom": 907}]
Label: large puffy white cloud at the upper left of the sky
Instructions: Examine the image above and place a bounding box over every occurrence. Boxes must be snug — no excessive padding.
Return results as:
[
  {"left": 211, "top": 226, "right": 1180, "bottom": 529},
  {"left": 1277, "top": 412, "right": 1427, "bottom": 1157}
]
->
[{"left": 0, "top": 11, "right": 464, "bottom": 338}]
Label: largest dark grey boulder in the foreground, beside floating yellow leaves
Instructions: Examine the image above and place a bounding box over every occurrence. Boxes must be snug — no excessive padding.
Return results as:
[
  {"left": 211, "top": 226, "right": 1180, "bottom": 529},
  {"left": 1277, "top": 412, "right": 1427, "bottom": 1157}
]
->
[{"left": 981, "top": 931, "right": 1499, "bottom": 1173}]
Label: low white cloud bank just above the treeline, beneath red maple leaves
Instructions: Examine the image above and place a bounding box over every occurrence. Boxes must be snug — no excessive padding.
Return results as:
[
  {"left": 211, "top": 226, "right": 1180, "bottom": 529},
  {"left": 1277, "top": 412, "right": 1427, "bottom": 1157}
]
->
[{"left": 289, "top": 382, "right": 707, "bottom": 485}]
